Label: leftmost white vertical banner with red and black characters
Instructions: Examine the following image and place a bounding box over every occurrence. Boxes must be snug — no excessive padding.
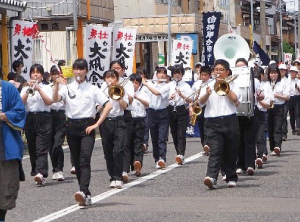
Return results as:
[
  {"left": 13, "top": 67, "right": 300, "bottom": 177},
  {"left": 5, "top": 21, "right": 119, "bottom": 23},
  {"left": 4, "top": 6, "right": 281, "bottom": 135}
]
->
[{"left": 11, "top": 20, "right": 38, "bottom": 81}]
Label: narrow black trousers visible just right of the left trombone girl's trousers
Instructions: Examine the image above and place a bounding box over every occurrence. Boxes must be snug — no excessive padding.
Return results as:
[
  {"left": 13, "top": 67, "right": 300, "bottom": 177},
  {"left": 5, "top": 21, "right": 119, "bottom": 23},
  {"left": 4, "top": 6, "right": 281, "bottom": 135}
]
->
[{"left": 123, "top": 110, "right": 133, "bottom": 173}]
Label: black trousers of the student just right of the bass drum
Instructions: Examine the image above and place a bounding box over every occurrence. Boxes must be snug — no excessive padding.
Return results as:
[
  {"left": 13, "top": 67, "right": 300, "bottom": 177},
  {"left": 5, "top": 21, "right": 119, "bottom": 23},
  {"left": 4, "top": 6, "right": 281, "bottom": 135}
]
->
[{"left": 254, "top": 107, "right": 267, "bottom": 158}]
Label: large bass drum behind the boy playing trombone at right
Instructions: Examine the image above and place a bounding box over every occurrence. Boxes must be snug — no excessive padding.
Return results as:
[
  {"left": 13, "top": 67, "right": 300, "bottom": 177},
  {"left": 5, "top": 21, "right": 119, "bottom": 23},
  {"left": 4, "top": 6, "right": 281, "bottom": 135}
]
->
[{"left": 231, "top": 67, "right": 254, "bottom": 117}]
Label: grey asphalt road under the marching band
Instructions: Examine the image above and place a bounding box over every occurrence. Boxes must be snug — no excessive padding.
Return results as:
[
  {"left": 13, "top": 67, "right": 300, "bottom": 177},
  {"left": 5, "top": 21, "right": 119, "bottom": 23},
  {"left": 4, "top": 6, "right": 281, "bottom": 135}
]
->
[{"left": 7, "top": 126, "right": 300, "bottom": 222}]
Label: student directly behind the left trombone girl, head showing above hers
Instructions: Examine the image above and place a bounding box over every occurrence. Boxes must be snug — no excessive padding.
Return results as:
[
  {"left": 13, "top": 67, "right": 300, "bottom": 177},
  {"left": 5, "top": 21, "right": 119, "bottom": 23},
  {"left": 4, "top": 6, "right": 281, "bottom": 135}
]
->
[{"left": 110, "top": 60, "right": 134, "bottom": 183}]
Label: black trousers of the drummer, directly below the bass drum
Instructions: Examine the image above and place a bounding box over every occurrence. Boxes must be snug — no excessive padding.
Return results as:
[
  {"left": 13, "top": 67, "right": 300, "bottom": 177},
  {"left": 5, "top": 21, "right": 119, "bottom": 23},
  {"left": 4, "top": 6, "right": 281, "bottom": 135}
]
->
[{"left": 237, "top": 116, "right": 256, "bottom": 170}]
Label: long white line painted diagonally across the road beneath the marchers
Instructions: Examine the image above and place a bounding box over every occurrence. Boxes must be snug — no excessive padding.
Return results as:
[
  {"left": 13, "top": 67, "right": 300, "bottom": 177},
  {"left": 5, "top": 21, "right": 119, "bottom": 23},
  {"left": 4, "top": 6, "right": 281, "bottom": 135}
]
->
[{"left": 34, "top": 152, "right": 203, "bottom": 222}]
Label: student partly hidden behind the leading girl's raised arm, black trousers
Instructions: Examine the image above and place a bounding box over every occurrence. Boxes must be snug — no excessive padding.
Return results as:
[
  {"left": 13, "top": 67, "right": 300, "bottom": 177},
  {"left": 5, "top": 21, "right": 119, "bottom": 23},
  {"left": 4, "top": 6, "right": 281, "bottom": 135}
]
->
[{"left": 49, "top": 65, "right": 67, "bottom": 181}]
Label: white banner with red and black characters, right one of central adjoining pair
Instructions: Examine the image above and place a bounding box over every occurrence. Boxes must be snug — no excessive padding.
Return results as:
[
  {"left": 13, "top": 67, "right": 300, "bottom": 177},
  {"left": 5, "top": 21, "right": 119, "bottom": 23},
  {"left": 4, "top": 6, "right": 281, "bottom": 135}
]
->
[{"left": 112, "top": 28, "right": 136, "bottom": 75}]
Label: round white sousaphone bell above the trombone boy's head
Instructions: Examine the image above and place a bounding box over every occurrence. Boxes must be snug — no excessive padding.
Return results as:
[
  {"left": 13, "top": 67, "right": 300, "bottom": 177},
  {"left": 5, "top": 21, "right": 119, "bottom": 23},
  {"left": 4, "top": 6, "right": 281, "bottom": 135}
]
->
[{"left": 214, "top": 33, "right": 250, "bottom": 67}]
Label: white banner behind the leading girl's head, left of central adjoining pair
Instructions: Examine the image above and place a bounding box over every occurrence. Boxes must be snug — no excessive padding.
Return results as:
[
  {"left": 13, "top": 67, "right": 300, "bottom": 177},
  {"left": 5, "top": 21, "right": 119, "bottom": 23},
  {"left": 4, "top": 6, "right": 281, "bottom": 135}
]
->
[{"left": 85, "top": 25, "right": 112, "bottom": 88}]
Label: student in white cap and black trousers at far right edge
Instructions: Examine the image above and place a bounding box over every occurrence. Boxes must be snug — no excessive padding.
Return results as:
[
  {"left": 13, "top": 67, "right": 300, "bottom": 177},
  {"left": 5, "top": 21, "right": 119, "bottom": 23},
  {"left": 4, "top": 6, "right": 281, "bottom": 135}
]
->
[{"left": 289, "top": 66, "right": 300, "bottom": 135}]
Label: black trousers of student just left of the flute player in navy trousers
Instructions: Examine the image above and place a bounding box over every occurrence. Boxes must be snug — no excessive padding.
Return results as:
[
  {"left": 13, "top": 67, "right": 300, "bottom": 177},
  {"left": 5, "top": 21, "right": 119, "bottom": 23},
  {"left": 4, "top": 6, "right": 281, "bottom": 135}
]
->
[{"left": 131, "top": 118, "right": 146, "bottom": 165}]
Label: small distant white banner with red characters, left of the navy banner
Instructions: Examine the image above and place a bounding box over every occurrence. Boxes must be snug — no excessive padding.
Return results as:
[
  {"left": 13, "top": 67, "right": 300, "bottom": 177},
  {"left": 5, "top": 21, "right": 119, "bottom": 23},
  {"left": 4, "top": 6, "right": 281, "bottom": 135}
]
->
[{"left": 172, "top": 40, "right": 193, "bottom": 68}]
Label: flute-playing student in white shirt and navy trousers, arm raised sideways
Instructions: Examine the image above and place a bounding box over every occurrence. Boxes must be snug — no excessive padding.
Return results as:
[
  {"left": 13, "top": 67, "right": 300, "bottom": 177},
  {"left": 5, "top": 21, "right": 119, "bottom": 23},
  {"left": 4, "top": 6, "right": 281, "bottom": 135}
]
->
[{"left": 143, "top": 67, "right": 170, "bottom": 169}]
